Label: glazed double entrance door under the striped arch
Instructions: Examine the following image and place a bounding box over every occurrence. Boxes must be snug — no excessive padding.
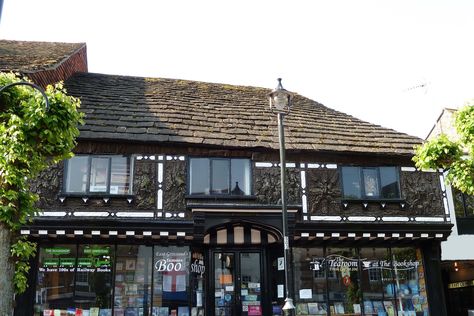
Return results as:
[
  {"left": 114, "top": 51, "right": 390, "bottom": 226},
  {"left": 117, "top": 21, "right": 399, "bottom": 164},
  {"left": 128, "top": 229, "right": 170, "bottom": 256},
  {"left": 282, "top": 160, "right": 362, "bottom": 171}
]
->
[{"left": 211, "top": 250, "right": 265, "bottom": 316}]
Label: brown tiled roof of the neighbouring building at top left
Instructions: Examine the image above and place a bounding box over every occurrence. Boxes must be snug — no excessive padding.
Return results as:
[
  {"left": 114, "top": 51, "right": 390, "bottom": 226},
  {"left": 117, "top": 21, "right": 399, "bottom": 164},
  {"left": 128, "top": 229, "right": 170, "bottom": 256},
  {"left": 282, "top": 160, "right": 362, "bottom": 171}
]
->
[{"left": 0, "top": 40, "right": 86, "bottom": 73}]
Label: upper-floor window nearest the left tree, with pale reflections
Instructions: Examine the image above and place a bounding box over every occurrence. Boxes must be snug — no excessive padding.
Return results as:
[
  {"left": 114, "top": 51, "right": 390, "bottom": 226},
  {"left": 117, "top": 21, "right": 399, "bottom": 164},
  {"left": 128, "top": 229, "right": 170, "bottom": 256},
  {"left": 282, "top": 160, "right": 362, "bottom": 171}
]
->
[{"left": 65, "top": 155, "right": 132, "bottom": 195}]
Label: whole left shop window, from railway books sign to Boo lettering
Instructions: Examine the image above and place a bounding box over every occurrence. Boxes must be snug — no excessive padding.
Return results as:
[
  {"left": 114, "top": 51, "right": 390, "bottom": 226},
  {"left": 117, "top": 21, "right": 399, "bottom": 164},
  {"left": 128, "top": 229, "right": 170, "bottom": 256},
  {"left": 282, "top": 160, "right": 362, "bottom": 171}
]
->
[{"left": 33, "top": 244, "right": 204, "bottom": 316}]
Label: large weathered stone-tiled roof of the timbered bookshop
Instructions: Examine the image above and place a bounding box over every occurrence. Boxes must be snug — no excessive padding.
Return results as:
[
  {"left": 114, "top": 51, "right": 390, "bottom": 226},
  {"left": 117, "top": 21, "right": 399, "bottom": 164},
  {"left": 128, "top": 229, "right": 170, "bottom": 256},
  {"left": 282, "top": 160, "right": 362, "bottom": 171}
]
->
[{"left": 66, "top": 73, "right": 422, "bottom": 155}]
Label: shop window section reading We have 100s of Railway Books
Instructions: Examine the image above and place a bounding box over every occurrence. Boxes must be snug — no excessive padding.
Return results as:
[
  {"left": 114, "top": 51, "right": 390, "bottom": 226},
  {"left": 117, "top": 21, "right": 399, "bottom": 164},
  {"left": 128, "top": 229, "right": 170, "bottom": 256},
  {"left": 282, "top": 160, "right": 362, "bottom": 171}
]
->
[{"left": 34, "top": 245, "right": 114, "bottom": 316}]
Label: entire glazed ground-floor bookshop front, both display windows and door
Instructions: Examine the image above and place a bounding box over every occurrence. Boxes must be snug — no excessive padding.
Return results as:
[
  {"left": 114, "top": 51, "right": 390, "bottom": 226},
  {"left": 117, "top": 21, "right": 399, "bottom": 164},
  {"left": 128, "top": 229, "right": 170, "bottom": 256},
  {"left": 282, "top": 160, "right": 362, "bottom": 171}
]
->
[{"left": 28, "top": 243, "right": 429, "bottom": 316}]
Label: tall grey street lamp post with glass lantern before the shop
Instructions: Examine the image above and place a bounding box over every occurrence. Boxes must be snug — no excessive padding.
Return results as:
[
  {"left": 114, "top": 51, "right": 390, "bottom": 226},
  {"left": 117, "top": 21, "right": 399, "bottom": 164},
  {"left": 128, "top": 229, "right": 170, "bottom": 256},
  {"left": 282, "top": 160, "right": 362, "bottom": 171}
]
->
[{"left": 268, "top": 78, "right": 295, "bottom": 315}]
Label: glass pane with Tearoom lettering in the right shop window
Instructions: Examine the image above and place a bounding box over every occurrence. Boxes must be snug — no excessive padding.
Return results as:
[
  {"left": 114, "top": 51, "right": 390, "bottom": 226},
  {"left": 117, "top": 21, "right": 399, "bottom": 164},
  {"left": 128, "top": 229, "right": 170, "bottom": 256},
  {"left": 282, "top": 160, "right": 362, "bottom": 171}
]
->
[{"left": 323, "top": 248, "right": 362, "bottom": 315}]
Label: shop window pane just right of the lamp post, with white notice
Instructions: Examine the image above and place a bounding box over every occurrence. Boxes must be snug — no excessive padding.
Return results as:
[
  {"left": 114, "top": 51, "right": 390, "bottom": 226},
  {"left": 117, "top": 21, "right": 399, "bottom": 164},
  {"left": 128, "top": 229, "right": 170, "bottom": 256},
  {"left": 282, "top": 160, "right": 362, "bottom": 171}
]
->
[{"left": 293, "top": 248, "right": 335, "bottom": 315}]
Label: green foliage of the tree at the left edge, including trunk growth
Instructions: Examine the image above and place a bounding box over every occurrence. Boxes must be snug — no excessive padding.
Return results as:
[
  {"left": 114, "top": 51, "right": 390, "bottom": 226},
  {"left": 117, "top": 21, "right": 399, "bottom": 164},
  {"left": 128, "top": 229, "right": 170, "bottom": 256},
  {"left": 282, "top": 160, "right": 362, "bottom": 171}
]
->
[{"left": 0, "top": 73, "right": 82, "bottom": 294}]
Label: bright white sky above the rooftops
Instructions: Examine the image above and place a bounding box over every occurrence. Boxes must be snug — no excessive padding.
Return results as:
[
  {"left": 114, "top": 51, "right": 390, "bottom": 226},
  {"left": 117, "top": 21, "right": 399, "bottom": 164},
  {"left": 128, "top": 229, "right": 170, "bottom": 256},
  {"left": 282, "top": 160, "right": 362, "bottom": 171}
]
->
[{"left": 0, "top": 0, "right": 474, "bottom": 138}]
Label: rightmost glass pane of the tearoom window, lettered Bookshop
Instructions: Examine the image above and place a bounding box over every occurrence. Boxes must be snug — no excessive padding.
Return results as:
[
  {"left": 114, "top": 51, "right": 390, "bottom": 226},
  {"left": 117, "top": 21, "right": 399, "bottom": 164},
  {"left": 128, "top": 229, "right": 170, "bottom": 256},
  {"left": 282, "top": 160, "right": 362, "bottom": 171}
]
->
[{"left": 392, "top": 248, "right": 429, "bottom": 315}]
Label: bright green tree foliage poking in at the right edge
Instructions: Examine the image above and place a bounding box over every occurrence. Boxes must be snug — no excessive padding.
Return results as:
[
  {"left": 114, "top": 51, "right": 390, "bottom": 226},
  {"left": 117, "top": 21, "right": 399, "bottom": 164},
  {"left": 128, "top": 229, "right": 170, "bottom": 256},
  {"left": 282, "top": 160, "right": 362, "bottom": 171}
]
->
[{"left": 413, "top": 101, "right": 474, "bottom": 195}]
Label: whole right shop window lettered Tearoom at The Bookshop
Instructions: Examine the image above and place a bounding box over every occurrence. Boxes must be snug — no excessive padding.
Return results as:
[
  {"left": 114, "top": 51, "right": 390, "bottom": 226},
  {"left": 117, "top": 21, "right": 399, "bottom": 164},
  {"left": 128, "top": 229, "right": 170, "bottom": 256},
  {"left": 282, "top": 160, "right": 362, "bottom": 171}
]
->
[{"left": 293, "top": 247, "right": 429, "bottom": 316}]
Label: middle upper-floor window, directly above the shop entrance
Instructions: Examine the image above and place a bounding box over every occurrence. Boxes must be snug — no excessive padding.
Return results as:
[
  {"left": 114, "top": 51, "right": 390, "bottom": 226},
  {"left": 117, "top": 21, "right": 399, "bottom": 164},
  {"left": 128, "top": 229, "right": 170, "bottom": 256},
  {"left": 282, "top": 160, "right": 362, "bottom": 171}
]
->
[{"left": 189, "top": 158, "right": 251, "bottom": 195}]
